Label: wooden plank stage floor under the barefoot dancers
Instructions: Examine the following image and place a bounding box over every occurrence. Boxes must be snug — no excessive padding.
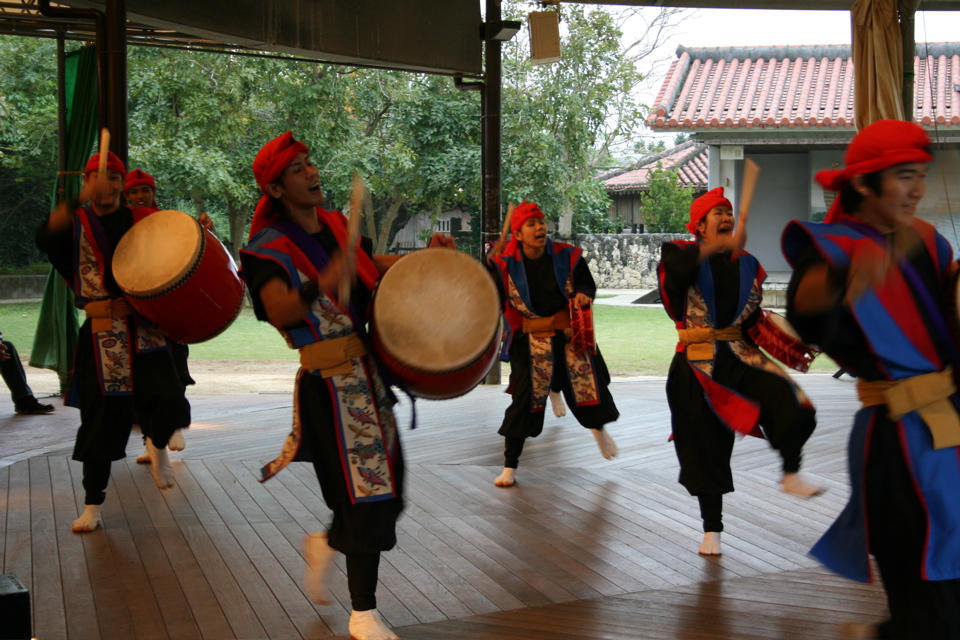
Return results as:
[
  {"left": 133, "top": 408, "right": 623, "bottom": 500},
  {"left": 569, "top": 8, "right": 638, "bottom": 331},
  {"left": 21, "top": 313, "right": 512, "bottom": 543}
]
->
[{"left": 0, "top": 375, "right": 886, "bottom": 640}]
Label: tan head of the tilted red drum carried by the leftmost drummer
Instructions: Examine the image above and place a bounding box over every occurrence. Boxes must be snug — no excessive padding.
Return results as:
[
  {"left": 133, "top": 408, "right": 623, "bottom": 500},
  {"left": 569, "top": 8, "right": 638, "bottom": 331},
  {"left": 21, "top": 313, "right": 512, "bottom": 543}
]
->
[{"left": 113, "top": 210, "right": 203, "bottom": 298}]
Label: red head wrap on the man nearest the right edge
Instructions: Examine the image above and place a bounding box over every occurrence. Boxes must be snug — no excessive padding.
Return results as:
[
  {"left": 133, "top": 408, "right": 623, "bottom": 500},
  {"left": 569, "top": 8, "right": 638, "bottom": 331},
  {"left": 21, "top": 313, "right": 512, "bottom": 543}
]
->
[{"left": 816, "top": 120, "right": 933, "bottom": 222}]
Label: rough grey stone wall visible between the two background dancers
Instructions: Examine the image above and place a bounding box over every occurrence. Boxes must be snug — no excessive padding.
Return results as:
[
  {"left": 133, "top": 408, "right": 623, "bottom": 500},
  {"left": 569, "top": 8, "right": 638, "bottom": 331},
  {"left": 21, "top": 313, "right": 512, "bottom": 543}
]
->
[{"left": 570, "top": 233, "right": 690, "bottom": 289}]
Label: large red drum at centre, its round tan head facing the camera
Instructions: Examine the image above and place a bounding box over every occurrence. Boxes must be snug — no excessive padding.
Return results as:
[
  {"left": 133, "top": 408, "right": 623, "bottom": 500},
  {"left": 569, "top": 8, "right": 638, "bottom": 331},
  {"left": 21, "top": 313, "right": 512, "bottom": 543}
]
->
[{"left": 370, "top": 248, "right": 501, "bottom": 400}]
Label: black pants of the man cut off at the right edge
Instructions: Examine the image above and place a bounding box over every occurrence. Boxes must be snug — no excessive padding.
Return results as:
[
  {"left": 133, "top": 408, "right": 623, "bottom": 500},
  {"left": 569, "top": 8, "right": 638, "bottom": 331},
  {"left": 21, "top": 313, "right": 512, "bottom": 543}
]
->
[{"left": 866, "top": 416, "right": 960, "bottom": 640}]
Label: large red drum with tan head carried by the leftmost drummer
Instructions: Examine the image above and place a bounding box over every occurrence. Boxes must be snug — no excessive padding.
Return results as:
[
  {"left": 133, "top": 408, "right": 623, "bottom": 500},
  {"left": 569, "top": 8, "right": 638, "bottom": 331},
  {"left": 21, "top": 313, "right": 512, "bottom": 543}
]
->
[{"left": 113, "top": 211, "right": 244, "bottom": 344}]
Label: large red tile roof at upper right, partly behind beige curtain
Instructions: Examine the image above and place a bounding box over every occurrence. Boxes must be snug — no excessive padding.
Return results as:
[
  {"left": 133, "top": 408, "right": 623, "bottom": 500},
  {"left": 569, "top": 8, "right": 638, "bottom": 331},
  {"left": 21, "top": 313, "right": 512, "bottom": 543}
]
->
[{"left": 647, "top": 42, "right": 960, "bottom": 131}]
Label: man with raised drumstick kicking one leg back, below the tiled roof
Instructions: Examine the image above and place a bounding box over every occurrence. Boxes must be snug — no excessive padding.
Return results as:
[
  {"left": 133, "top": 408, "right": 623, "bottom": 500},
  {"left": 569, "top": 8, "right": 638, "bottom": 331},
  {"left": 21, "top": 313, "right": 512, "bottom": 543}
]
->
[{"left": 657, "top": 187, "right": 820, "bottom": 555}]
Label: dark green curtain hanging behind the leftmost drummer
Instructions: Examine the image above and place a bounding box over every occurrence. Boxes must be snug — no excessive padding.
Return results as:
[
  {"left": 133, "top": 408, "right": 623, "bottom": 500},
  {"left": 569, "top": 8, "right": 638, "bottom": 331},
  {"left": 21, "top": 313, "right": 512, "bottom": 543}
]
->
[{"left": 29, "top": 45, "right": 97, "bottom": 393}]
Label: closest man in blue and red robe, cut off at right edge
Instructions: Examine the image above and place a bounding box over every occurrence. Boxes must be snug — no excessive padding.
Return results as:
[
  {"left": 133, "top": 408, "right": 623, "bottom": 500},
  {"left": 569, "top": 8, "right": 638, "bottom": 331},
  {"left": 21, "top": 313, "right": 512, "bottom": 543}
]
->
[{"left": 783, "top": 120, "right": 960, "bottom": 640}]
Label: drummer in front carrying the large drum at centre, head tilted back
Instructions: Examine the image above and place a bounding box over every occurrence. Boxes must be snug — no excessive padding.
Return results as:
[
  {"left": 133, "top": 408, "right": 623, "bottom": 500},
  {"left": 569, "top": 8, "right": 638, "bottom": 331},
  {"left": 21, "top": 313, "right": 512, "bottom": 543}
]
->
[{"left": 240, "top": 131, "right": 453, "bottom": 640}]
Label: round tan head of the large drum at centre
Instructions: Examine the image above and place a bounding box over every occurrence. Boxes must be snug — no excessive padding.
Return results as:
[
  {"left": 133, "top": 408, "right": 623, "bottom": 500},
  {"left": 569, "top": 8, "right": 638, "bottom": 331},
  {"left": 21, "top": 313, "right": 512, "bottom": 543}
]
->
[{"left": 373, "top": 248, "right": 500, "bottom": 373}]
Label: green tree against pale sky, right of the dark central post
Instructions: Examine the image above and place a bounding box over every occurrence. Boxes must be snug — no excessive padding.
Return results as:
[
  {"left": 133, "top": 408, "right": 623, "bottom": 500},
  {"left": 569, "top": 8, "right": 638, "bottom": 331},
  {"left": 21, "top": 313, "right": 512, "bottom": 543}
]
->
[{"left": 503, "top": 2, "right": 681, "bottom": 235}]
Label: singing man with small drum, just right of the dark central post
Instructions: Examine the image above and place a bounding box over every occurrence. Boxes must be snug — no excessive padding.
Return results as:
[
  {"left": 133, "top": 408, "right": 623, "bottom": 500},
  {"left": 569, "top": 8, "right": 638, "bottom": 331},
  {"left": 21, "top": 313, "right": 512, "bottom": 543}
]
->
[{"left": 488, "top": 201, "right": 620, "bottom": 487}]
